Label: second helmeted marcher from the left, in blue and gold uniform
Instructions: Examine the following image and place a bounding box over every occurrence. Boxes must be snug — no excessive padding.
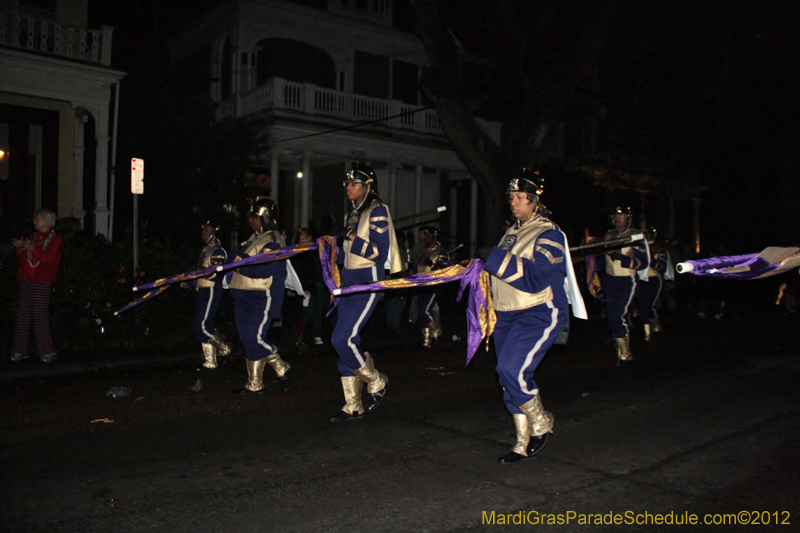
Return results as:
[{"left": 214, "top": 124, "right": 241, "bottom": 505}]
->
[{"left": 229, "top": 198, "right": 291, "bottom": 393}]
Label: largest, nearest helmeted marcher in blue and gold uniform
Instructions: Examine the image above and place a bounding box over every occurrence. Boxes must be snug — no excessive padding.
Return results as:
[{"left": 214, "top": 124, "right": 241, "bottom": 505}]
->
[{"left": 484, "top": 169, "right": 570, "bottom": 464}]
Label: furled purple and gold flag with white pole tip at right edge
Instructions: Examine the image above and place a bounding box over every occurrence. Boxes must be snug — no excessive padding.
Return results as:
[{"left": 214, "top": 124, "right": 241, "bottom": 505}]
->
[{"left": 675, "top": 246, "right": 800, "bottom": 279}]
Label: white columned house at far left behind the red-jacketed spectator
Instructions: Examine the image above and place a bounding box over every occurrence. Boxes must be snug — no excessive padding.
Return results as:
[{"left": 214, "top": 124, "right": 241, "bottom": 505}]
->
[{"left": 0, "top": 0, "right": 125, "bottom": 236}]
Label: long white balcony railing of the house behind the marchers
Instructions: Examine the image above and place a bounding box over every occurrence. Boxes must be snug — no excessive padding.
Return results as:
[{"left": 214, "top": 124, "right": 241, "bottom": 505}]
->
[{"left": 217, "top": 78, "right": 502, "bottom": 144}]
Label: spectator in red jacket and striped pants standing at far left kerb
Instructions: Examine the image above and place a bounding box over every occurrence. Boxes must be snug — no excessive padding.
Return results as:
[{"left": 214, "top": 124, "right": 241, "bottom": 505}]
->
[{"left": 11, "top": 209, "right": 64, "bottom": 363}]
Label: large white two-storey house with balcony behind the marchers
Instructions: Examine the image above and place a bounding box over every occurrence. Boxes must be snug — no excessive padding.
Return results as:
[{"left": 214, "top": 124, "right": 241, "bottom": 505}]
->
[{"left": 168, "top": 0, "right": 500, "bottom": 253}]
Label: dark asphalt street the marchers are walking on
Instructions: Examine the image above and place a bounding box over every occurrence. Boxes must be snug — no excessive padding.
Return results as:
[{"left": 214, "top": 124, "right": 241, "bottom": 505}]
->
[{"left": 0, "top": 290, "right": 800, "bottom": 532}]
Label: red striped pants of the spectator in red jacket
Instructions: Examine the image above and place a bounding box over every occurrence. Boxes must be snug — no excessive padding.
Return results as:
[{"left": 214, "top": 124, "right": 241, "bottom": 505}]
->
[{"left": 11, "top": 279, "right": 56, "bottom": 356}]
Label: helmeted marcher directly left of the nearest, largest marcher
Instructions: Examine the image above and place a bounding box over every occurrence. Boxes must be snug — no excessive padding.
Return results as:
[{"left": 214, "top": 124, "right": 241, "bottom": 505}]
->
[{"left": 330, "top": 165, "right": 402, "bottom": 422}]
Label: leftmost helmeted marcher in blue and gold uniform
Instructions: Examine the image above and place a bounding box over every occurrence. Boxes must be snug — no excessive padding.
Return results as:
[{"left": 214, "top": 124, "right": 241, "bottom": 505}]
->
[{"left": 194, "top": 221, "right": 231, "bottom": 368}]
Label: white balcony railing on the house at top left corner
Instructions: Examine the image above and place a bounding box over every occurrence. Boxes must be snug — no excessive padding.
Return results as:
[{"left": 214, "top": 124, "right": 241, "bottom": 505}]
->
[{"left": 0, "top": 13, "right": 114, "bottom": 66}]
